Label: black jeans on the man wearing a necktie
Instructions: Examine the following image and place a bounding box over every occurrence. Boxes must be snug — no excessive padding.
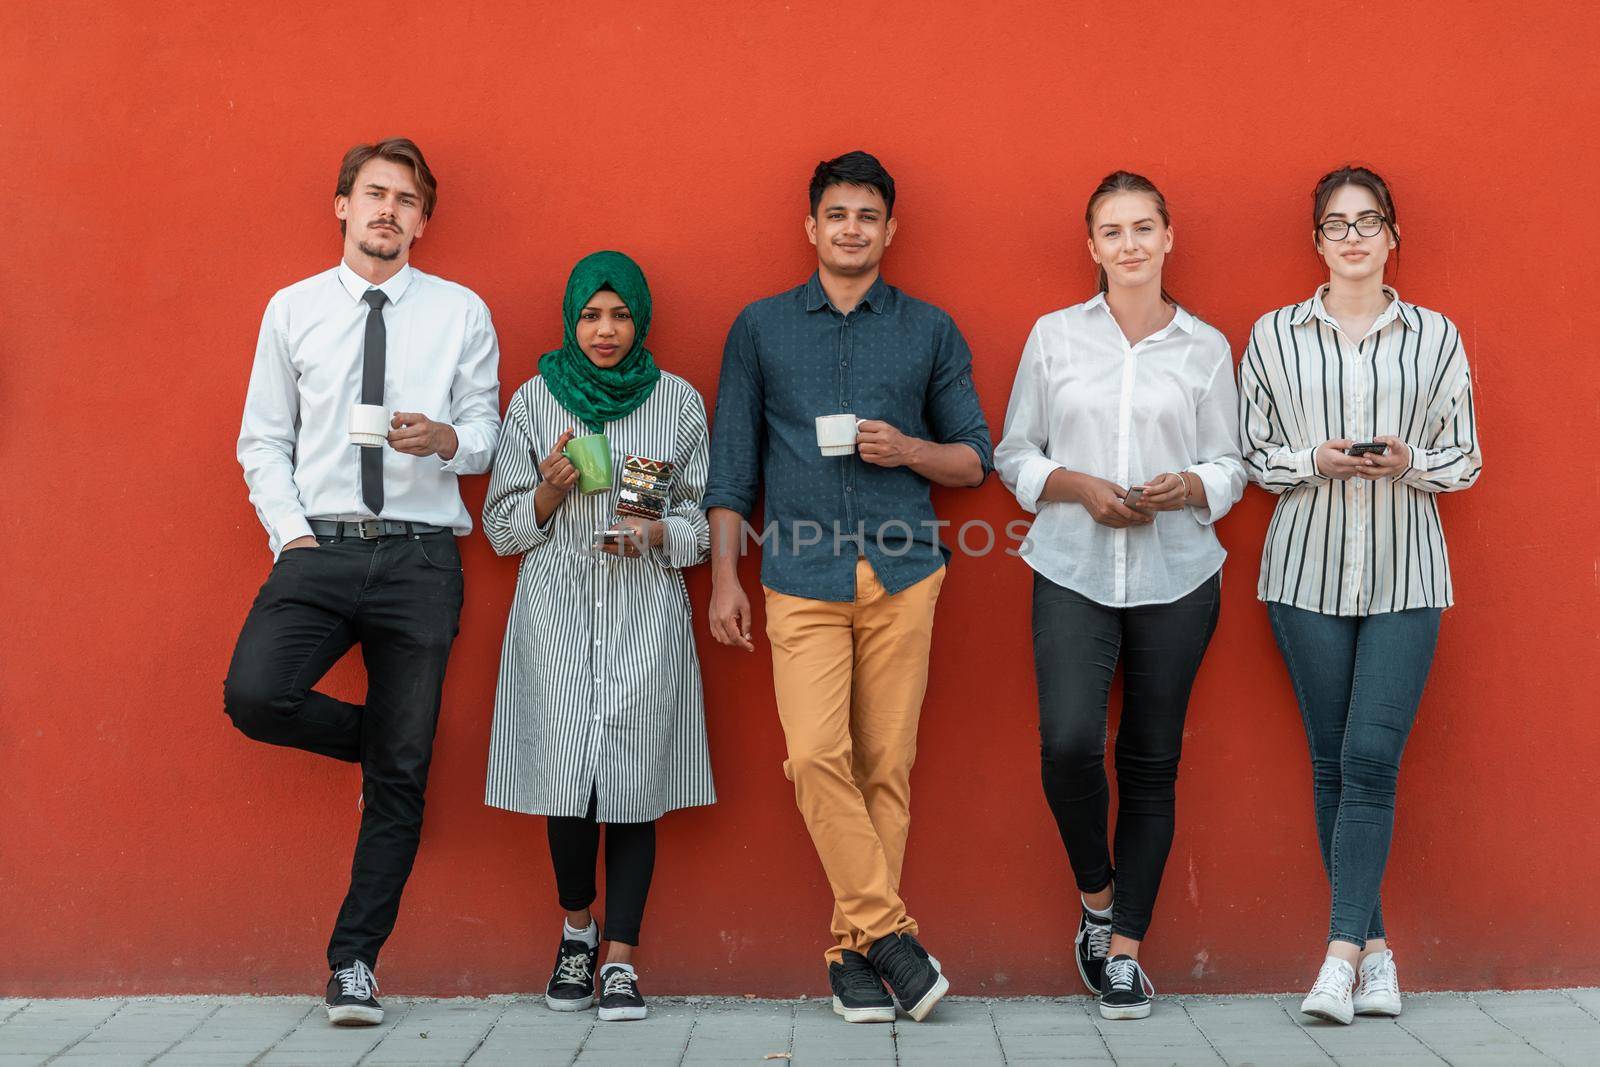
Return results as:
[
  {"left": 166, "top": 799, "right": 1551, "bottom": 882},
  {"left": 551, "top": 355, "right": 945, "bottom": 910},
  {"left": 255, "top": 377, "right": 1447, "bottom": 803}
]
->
[{"left": 222, "top": 533, "right": 461, "bottom": 966}]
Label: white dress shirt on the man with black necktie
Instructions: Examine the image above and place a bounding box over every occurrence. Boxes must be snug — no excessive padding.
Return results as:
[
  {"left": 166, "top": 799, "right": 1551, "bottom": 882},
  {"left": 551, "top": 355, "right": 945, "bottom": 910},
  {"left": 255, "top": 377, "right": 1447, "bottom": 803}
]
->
[{"left": 238, "top": 262, "right": 499, "bottom": 555}]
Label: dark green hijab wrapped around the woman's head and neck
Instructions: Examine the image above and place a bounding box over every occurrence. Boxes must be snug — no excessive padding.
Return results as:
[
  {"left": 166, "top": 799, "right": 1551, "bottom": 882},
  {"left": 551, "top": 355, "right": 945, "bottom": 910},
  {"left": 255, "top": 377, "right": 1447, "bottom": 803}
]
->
[{"left": 539, "top": 251, "right": 661, "bottom": 434}]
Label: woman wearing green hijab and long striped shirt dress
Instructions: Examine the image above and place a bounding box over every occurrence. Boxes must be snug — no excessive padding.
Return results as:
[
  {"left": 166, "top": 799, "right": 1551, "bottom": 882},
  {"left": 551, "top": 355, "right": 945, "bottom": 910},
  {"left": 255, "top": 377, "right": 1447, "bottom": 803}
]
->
[{"left": 483, "top": 251, "right": 715, "bottom": 1021}]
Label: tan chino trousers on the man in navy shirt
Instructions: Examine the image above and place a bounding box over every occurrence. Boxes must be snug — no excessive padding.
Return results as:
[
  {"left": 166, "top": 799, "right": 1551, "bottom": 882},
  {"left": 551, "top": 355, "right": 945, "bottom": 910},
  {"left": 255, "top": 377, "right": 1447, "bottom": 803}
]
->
[{"left": 765, "top": 557, "right": 944, "bottom": 963}]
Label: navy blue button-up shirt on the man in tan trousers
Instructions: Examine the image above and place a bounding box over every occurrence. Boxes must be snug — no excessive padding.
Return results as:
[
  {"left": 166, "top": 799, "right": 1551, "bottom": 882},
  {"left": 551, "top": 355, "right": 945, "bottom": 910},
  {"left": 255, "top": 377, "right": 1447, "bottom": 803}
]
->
[{"left": 702, "top": 274, "right": 994, "bottom": 601}]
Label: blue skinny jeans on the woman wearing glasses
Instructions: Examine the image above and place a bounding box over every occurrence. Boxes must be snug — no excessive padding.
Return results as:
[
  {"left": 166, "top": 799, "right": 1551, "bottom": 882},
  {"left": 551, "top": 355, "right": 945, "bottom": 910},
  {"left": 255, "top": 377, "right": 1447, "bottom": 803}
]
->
[{"left": 1267, "top": 603, "right": 1440, "bottom": 947}]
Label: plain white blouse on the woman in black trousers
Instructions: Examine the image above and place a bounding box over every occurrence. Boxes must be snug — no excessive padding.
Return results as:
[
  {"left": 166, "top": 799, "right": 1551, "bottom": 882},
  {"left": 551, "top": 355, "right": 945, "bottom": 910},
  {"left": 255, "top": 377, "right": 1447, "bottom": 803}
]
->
[{"left": 995, "top": 294, "right": 1245, "bottom": 608}]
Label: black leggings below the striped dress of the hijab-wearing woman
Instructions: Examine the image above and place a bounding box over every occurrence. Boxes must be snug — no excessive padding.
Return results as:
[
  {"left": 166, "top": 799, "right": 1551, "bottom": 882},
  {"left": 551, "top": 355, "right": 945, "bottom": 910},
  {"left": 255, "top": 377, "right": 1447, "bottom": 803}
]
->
[{"left": 544, "top": 795, "right": 656, "bottom": 945}]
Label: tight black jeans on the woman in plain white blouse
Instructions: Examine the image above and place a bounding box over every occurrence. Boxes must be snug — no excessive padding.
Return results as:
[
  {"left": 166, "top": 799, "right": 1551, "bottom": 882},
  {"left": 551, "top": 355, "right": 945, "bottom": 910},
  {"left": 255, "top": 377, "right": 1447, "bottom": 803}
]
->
[{"left": 1034, "top": 571, "right": 1222, "bottom": 941}]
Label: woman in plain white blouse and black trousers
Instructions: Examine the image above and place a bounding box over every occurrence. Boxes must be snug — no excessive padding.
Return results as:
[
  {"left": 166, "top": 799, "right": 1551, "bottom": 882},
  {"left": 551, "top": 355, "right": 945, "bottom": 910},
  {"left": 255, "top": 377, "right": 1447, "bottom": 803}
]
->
[{"left": 995, "top": 171, "right": 1245, "bottom": 1019}]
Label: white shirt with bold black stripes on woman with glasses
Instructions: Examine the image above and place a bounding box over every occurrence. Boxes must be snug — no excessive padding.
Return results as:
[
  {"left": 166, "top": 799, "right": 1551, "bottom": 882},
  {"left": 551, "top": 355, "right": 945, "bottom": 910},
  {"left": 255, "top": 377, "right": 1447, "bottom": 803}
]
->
[{"left": 1238, "top": 288, "right": 1483, "bottom": 616}]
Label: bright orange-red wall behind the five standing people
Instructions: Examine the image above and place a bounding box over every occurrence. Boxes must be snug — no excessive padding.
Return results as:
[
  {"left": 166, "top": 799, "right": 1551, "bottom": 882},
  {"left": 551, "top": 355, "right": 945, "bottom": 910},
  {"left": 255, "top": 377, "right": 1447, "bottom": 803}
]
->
[{"left": 0, "top": 0, "right": 1600, "bottom": 995}]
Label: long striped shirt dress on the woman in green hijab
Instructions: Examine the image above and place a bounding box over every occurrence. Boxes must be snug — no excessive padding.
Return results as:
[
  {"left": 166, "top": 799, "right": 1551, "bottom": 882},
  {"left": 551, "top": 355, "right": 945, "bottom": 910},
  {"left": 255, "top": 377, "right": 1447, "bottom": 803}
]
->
[{"left": 483, "top": 371, "right": 715, "bottom": 822}]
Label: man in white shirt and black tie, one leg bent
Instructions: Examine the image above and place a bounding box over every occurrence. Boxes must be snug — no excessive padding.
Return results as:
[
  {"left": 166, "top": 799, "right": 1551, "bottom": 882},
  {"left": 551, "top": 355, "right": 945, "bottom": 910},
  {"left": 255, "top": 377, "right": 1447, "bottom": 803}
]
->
[{"left": 224, "top": 138, "right": 499, "bottom": 1025}]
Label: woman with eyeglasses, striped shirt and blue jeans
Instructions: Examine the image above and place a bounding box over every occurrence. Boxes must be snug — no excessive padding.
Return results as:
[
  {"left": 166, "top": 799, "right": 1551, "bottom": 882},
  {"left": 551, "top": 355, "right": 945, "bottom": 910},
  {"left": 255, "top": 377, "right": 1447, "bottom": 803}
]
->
[{"left": 1238, "top": 166, "right": 1482, "bottom": 1022}]
